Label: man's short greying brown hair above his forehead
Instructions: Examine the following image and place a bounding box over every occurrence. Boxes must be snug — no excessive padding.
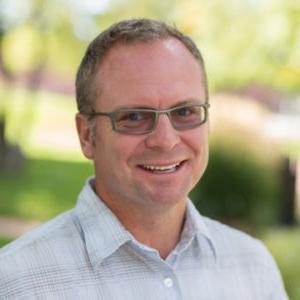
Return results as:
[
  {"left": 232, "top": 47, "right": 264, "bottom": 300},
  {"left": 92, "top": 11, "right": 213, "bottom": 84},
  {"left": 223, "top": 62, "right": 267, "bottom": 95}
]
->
[{"left": 76, "top": 19, "right": 208, "bottom": 113}]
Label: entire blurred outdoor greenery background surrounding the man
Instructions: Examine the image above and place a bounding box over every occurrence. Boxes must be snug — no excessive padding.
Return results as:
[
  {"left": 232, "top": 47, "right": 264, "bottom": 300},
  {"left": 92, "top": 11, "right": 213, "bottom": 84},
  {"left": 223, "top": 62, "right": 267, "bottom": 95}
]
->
[{"left": 0, "top": 0, "right": 300, "bottom": 300}]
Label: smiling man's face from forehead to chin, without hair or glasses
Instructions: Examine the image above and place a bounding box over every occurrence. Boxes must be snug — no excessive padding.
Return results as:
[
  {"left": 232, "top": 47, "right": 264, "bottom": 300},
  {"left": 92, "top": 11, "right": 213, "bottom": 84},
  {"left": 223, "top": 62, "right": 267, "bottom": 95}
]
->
[{"left": 78, "top": 39, "right": 208, "bottom": 210}]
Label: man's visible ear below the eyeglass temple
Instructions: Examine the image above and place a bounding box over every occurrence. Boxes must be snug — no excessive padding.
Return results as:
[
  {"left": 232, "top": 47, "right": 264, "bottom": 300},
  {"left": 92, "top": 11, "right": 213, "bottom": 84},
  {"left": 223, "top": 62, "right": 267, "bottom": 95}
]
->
[{"left": 76, "top": 113, "right": 94, "bottom": 159}]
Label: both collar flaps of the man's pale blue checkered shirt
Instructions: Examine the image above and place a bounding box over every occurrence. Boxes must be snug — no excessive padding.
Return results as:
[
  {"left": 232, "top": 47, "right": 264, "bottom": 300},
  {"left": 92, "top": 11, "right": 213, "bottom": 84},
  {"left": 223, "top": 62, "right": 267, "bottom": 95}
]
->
[{"left": 74, "top": 178, "right": 217, "bottom": 267}]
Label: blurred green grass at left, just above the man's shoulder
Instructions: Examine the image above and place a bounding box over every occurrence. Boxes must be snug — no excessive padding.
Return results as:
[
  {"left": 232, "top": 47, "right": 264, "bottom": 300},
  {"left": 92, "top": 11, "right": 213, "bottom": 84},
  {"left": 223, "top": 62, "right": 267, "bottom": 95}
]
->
[{"left": 0, "top": 158, "right": 92, "bottom": 221}]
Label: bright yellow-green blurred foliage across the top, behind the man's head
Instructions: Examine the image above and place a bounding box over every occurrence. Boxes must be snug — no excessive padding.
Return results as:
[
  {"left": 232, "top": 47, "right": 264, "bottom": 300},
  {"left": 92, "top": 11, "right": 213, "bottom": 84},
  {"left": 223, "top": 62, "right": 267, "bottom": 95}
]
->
[{"left": 0, "top": 0, "right": 300, "bottom": 91}]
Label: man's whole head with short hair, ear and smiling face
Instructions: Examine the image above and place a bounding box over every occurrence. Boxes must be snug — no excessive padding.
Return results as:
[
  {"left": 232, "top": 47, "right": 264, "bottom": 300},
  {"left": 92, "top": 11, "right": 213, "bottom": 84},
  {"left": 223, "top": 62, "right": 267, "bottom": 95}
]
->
[{"left": 77, "top": 20, "right": 208, "bottom": 211}]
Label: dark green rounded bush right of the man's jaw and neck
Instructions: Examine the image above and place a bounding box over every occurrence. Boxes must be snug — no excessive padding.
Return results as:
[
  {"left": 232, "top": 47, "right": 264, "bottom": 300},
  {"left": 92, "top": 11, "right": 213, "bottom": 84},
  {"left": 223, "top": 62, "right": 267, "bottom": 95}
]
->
[{"left": 190, "top": 137, "right": 281, "bottom": 227}]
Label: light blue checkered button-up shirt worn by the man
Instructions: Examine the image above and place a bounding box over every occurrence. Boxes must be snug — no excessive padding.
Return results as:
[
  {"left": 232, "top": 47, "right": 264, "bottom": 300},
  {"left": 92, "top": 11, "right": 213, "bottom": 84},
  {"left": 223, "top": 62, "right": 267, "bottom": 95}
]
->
[{"left": 0, "top": 179, "right": 287, "bottom": 300}]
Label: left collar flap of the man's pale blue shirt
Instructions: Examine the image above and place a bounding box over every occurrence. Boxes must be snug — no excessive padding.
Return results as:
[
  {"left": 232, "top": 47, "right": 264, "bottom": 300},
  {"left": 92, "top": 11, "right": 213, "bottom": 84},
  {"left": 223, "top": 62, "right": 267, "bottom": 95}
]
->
[{"left": 74, "top": 178, "right": 131, "bottom": 267}]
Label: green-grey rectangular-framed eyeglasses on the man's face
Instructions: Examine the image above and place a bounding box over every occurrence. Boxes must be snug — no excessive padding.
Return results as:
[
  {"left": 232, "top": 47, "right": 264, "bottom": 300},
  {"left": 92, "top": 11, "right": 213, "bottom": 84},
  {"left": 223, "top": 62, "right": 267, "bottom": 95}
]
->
[{"left": 85, "top": 103, "right": 210, "bottom": 135}]
